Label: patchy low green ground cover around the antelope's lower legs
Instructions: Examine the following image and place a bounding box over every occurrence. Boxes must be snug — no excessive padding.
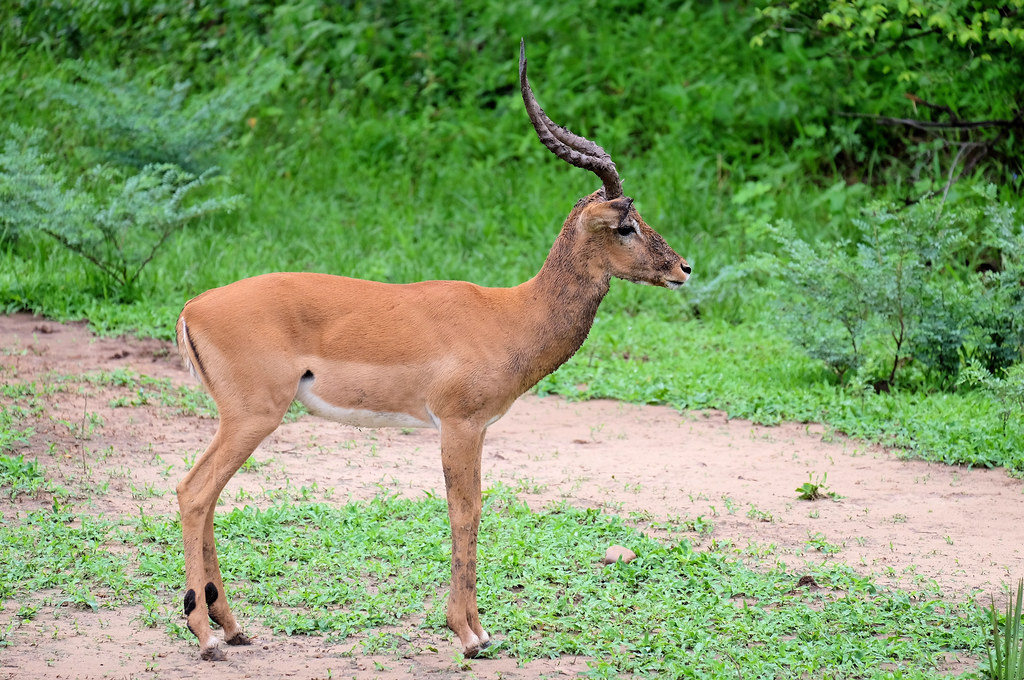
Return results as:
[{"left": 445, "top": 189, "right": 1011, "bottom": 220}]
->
[{"left": 0, "top": 487, "right": 987, "bottom": 678}]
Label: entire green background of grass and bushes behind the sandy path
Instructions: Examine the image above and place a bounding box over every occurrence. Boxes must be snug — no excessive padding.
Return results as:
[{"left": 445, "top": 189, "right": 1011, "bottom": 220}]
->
[{"left": 6, "top": 0, "right": 1024, "bottom": 471}]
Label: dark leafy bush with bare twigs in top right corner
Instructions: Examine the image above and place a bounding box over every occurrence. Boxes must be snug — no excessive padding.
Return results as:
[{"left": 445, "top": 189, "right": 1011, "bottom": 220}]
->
[{"left": 752, "top": 0, "right": 1024, "bottom": 191}]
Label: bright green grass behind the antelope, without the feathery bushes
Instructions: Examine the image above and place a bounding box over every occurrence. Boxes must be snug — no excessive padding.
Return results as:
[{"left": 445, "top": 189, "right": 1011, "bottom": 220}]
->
[{"left": 0, "top": 0, "right": 1024, "bottom": 473}]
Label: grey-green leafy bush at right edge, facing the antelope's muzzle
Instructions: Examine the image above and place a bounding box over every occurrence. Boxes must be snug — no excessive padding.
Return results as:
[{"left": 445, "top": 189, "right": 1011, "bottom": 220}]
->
[{"left": 759, "top": 193, "right": 1024, "bottom": 390}]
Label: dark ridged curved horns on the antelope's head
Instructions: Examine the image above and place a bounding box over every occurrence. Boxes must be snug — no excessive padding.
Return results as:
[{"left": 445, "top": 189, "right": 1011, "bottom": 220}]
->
[{"left": 519, "top": 40, "right": 623, "bottom": 201}]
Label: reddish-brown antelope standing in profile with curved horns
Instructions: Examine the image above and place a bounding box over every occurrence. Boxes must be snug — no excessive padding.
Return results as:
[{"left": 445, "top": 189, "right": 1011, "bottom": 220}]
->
[{"left": 176, "top": 42, "right": 690, "bottom": 661}]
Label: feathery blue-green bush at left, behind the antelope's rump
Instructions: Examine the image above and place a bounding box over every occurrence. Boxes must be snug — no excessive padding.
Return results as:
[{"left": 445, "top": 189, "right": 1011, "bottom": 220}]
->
[{"left": 0, "top": 59, "right": 286, "bottom": 300}]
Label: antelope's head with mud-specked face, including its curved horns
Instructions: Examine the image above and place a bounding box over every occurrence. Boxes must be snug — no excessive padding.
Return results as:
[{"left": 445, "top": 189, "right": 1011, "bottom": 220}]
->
[{"left": 519, "top": 41, "right": 690, "bottom": 289}]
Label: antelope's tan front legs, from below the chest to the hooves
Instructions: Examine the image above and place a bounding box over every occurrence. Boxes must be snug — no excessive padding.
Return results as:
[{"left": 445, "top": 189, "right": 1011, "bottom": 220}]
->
[{"left": 441, "top": 422, "right": 490, "bottom": 657}]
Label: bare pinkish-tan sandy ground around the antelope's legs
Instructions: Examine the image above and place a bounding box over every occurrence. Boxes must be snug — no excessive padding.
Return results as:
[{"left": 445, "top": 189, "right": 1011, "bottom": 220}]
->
[{"left": 0, "top": 314, "right": 1024, "bottom": 679}]
